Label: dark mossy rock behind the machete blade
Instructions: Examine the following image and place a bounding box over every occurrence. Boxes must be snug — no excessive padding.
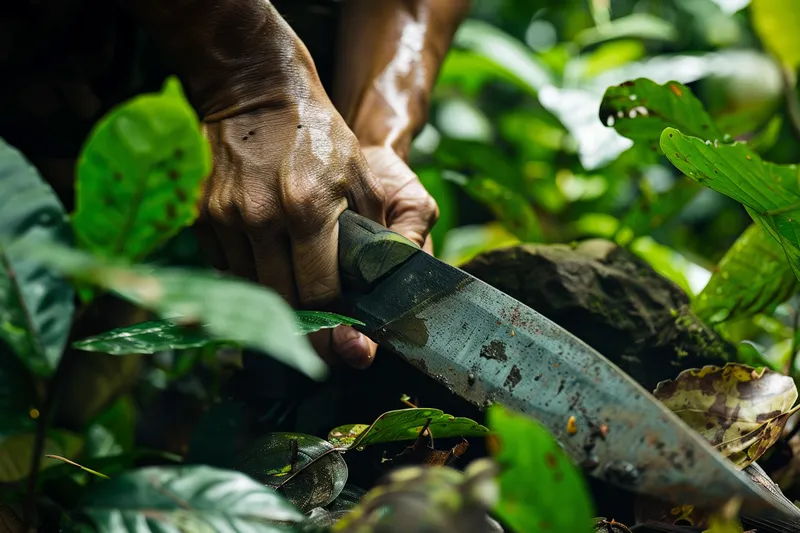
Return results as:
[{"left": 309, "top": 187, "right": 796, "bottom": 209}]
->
[{"left": 461, "top": 239, "right": 735, "bottom": 390}]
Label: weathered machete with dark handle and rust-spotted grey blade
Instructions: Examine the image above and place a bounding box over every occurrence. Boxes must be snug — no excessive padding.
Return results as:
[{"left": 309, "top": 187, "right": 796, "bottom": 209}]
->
[{"left": 339, "top": 210, "right": 797, "bottom": 517}]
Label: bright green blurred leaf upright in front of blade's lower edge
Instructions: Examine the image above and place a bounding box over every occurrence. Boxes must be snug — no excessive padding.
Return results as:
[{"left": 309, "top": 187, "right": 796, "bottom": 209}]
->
[{"left": 487, "top": 404, "right": 594, "bottom": 533}]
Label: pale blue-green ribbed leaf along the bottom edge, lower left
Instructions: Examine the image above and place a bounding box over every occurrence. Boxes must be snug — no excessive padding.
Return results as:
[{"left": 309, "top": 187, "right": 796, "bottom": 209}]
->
[{"left": 81, "top": 466, "right": 305, "bottom": 533}]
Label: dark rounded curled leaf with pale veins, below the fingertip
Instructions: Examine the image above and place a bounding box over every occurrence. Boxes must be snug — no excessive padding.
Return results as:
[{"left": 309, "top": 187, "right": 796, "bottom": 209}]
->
[{"left": 234, "top": 433, "right": 348, "bottom": 512}]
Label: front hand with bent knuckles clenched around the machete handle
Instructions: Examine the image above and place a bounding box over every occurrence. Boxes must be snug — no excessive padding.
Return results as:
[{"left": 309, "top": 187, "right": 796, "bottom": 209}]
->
[{"left": 198, "top": 85, "right": 385, "bottom": 367}]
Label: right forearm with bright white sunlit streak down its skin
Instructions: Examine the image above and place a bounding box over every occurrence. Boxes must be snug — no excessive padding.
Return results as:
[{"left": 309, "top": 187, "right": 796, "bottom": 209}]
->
[{"left": 334, "top": 0, "right": 470, "bottom": 158}]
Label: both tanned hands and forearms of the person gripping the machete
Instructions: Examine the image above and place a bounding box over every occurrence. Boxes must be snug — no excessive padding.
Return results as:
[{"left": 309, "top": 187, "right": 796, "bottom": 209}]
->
[{"left": 117, "top": 0, "right": 468, "bottom": 367}]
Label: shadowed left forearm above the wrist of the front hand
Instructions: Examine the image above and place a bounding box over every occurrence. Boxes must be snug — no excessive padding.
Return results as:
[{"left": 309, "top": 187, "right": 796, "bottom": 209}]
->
[{"left": 125, "top": 0, "right": 318, "bottom": 120}]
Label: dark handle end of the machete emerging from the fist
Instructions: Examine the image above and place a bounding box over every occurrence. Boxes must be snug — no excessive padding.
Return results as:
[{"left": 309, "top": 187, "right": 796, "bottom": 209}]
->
[{"left": 339, "top": 209, "right": 422, "bottom": 296}]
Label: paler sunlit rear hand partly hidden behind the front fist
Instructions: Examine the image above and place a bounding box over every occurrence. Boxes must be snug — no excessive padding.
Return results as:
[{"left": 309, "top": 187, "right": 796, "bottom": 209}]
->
[{"left": 324, "top": 146, "right": 439, "bottom": 367}]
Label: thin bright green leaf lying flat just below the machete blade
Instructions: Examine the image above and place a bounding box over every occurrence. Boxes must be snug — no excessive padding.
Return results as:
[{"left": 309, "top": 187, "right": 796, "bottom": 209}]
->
[{"left": 328, "top": 408, "right": 489, "bottom": 448}]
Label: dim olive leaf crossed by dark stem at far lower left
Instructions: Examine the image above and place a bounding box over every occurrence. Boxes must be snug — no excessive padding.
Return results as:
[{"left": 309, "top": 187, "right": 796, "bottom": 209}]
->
[{"left": 0, "top": 430, "right": 83, "bottom": 483}]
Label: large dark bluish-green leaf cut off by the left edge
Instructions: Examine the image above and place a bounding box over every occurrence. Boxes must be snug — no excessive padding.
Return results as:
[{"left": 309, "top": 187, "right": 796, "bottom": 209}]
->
[{"left": 0, "top": 139, "right": 74, "bottom": 377}]
